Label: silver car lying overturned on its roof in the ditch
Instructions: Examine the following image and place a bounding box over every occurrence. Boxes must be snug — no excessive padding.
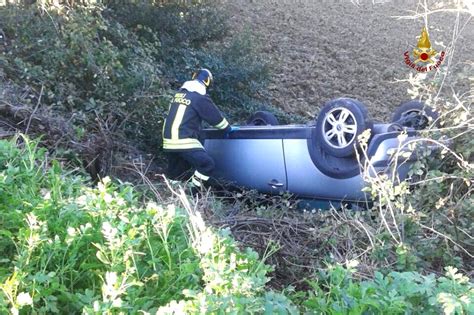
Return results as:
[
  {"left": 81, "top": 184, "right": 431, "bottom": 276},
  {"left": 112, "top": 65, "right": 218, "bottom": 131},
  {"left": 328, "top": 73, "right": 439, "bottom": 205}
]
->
[{"left": 202, "top": 98, "right": 437, "bottom": 202}]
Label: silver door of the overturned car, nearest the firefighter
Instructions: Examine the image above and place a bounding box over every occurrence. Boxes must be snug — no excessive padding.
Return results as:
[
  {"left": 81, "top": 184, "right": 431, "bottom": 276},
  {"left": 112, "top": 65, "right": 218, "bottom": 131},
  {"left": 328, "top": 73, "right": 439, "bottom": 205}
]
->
[{"left": 205, "top": 128, "right": 287, "bottom": 193}]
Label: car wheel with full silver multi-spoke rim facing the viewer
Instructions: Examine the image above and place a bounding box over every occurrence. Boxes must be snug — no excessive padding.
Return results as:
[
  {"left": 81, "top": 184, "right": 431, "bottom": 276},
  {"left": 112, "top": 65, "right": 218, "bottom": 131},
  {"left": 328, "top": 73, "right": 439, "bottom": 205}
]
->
[{"left": 316, "top": 98, "right": 370, "bottom": 157}]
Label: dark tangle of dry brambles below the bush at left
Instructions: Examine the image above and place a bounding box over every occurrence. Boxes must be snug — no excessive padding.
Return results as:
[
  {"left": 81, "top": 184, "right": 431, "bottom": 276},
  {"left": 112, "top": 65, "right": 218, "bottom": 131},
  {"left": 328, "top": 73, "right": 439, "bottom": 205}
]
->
[{"left": 0, "top": 81, "right": 157, "bottom": 181}]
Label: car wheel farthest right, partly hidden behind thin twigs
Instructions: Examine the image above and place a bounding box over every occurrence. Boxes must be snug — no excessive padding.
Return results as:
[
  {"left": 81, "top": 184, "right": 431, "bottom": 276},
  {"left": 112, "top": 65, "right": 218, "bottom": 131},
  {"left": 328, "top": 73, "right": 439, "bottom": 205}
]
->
[{"left": 392, "top": 101, "right": 439, "bottom": 130}]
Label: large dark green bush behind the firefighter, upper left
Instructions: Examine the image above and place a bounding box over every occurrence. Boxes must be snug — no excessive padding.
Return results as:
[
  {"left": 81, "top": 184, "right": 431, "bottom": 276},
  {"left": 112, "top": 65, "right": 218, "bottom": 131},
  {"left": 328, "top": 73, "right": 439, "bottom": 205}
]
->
[{"left": 0, "top": 1, "right": 283, "bottom": 153}]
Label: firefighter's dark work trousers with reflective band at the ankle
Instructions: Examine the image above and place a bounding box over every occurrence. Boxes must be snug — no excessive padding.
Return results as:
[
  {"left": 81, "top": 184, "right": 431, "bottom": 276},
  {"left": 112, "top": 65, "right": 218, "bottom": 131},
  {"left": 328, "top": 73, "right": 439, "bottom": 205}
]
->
[{"left": 166, "top": 150, "right": 215, "bottom": 187}]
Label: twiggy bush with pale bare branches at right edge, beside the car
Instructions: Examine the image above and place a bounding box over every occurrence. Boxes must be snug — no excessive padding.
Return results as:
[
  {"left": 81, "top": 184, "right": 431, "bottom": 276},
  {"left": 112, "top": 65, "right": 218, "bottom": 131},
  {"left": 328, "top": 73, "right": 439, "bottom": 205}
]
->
[{"left": 352, "top": 75, "right": 474, "bottom": 272}]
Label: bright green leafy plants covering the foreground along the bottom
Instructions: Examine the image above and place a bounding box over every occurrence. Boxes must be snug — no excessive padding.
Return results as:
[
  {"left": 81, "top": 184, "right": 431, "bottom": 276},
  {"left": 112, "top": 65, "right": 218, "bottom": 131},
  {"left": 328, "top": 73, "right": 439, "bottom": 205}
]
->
[{"left": 0, "top": 136, "right": 474, "bottom": 314}]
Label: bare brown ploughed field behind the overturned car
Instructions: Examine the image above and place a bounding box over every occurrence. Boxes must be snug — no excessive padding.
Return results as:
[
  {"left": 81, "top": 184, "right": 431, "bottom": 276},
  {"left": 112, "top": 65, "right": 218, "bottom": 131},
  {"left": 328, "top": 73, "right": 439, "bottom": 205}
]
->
[{"left": 225, "top": 0, "right": 474, "bottom": 120}]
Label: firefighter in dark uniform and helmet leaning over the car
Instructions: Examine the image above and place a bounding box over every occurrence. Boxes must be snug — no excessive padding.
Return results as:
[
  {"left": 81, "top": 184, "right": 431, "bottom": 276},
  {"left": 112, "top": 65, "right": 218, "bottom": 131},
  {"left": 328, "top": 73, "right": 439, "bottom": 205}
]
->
[{"left": 163, "top": 69, "right": 237, "bottom": 189}]
